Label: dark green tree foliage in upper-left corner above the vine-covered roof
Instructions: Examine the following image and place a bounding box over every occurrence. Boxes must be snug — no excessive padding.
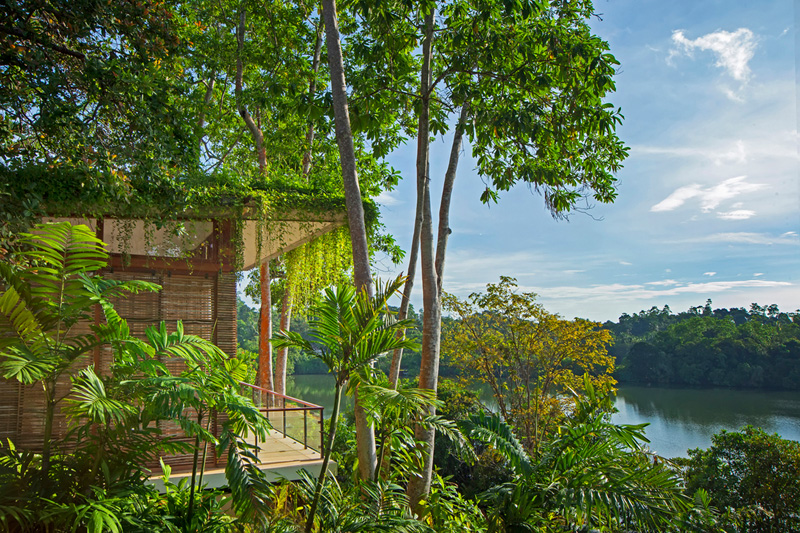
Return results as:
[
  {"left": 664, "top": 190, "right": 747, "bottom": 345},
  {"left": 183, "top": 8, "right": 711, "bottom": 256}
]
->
[{"left": 0, "top": 0, "right": 192, "bottom": 185}]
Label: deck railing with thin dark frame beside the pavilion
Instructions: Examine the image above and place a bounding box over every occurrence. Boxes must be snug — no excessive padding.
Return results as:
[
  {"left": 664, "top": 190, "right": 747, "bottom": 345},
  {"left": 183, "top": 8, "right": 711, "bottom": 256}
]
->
[{"left": 239, "top": 381, "right": 325, "bottom": 453}]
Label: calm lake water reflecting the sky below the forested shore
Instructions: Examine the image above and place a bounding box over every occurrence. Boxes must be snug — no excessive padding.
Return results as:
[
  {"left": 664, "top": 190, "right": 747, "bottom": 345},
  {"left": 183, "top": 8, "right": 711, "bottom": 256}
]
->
[{"left": 287, "top": 375, "right": 800, "bottom": 457}]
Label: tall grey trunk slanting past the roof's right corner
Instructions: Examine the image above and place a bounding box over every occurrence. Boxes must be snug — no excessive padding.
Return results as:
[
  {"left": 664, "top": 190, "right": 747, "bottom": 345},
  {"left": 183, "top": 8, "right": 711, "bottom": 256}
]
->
[{"left": 322, "top": 0, "right": 377, "bottom": 480}]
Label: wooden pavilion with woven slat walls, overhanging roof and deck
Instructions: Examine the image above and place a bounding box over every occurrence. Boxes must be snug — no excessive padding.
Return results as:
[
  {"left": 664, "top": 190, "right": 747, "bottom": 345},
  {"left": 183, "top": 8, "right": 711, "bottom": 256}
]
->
[{"left": 0, "top": 210, "right": 346, "bottom": 486}]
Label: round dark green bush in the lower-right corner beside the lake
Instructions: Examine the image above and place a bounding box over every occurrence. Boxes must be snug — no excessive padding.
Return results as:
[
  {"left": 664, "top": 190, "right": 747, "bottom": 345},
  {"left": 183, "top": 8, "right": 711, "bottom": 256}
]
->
[{"left": 685, "top": 426, "right": 800, "bottom": 533}]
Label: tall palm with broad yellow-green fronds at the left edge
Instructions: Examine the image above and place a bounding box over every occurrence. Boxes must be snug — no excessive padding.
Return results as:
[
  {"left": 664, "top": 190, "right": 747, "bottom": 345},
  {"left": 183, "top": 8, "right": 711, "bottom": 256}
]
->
[{"left": 0, "top": 218, "right": 158, "bottom": 477}]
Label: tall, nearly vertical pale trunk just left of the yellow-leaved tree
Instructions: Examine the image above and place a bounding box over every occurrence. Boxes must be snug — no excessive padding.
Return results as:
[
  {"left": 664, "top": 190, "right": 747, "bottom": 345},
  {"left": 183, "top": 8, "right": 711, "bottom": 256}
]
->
[{"left": 408, "top": 7, "right": 441, "bottom": 515}]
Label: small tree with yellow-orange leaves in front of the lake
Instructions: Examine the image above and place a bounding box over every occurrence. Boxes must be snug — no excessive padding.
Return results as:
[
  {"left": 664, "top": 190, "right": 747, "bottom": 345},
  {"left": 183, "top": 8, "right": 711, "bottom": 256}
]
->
[{"left": 442, "top": 277, "right": 616, "bottom": 452}]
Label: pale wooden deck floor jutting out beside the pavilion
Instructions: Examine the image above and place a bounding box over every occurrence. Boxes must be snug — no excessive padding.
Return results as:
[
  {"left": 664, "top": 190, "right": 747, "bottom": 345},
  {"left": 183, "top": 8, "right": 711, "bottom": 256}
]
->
[{"left": 150, "top": 430, "right": 337, "bottom": 491}]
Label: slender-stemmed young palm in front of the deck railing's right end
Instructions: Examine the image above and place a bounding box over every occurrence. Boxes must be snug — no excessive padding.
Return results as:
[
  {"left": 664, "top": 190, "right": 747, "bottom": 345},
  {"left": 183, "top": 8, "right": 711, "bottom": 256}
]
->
[{"left": 272, "top": 278, "right": 413, "bottom": 532}]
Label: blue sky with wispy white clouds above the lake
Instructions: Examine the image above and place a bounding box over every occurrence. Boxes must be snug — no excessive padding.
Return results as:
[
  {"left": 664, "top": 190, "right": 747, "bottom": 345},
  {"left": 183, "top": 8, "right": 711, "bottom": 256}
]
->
[{"left": 375, "top": 0, "right": 800, "bottom": 321}]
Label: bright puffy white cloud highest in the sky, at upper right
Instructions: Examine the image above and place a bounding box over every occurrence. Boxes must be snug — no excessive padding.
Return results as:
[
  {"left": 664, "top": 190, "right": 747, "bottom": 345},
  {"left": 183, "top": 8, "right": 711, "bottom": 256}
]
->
[{"left": 670, "top": 28, "right": 756, "bottom": 82}]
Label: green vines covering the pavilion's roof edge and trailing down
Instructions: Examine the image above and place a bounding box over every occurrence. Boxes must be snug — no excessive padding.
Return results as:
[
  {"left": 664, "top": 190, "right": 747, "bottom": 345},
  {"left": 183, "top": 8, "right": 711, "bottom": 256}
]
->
[{"left": 0, "top": 165, "right": 380, "bottom": 272}]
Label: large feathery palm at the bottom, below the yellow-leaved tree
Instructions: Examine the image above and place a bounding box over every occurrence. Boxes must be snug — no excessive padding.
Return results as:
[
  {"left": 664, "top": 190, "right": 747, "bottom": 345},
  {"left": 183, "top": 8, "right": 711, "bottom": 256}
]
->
[{"left": 472, "top": 380, "right": 689, "bottom": 532}]
